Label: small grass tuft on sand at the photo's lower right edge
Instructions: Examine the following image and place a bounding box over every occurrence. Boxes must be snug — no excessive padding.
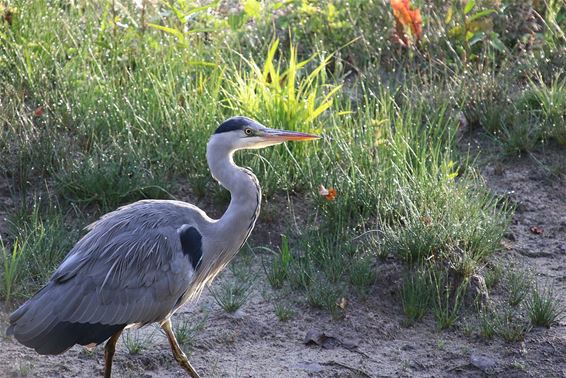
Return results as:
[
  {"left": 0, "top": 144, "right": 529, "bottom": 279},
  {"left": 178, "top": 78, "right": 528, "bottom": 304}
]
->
[{"left": 527, "top": 284, "right": 566, "bottom": 328}]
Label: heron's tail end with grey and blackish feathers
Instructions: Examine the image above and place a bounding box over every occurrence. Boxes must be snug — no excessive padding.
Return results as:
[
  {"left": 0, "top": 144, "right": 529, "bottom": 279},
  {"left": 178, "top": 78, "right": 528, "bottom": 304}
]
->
[{"left": 6, "top": 287, "right": 126, "bottom": 354}]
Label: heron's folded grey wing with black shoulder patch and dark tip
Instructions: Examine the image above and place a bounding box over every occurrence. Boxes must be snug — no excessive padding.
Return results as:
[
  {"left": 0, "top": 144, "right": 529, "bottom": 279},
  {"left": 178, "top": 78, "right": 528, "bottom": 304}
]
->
[{"left": 8, "top": 202, "right": 202, "bottom": 354}]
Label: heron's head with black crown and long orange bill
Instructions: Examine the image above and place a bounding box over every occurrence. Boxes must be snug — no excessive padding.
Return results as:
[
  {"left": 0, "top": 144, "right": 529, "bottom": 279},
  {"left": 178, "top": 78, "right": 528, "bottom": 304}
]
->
[{"left": 211, "top": 116, "right": 320, "bottom": 150}]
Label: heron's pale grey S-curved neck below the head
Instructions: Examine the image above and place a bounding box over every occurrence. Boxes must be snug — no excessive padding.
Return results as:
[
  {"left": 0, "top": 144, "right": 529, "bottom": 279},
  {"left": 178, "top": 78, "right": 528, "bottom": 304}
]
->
[{"left": 207, "top": 146, "right": 261, "bottom": 244}]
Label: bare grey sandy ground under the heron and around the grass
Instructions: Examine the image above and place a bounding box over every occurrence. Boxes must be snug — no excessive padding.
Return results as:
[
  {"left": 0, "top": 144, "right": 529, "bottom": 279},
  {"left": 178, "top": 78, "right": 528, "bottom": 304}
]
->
[{"left": 0, "top": 137, "right": 566, "bottom": 377}]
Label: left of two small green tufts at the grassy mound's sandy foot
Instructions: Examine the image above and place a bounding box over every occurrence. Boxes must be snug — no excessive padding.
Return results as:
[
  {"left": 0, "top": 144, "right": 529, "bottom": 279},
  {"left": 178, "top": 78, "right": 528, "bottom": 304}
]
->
[{"left": 401, "top": 271, "right": 432, "bottom": 326}]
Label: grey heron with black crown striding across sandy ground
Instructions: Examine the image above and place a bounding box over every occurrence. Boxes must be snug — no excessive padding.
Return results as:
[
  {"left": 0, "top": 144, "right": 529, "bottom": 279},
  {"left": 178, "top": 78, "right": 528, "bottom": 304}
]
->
[{"left": 7, "top": 117, "right": 319, "bottom": 377}]
